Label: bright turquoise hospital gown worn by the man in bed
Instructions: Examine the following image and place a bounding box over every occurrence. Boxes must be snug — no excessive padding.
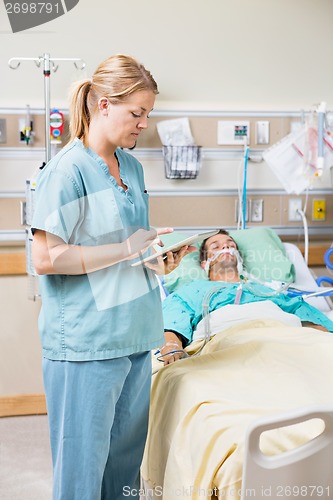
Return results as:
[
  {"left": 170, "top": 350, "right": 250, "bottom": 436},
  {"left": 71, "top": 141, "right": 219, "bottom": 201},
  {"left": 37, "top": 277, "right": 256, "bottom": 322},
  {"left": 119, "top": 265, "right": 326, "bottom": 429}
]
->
[{"left": 163, "top": 280, "right": 333, "bottom": 343}]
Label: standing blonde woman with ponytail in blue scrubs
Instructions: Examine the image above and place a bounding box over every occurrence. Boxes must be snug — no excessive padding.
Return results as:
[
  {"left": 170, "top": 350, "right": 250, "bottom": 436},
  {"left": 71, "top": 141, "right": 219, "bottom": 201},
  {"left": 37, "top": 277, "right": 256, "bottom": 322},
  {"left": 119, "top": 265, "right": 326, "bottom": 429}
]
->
[{"left": 32, "top": 55, "right": 188, "bottom": 500}]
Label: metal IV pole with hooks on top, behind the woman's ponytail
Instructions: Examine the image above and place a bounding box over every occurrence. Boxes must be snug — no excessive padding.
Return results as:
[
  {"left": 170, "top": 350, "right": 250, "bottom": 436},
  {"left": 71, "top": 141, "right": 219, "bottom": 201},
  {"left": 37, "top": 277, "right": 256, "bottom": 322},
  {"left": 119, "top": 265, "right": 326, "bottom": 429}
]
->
[{"left": 8, "top": 53, "right": 86, "bottom": 163}]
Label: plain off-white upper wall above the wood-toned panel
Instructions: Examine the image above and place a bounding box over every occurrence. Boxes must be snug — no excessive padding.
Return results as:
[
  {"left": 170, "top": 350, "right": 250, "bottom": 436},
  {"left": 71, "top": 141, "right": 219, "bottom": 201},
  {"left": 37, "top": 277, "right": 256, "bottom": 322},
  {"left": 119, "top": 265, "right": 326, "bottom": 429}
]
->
[{"left": 0, "top": 0, "right": 333, "bottom": 110}]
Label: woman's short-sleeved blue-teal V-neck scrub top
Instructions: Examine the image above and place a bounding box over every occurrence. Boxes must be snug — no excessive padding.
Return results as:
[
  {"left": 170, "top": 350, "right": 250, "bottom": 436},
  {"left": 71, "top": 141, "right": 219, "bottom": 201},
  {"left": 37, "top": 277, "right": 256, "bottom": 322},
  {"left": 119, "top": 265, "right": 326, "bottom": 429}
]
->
[{"left": 32, "top": 139, "right": 163, "bottom": 361}]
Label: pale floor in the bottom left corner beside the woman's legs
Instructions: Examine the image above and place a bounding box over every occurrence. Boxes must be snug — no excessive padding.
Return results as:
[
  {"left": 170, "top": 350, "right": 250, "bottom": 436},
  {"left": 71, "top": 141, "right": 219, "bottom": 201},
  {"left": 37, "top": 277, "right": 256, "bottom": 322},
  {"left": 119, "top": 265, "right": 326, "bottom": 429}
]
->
[{"left": 0, "top": 415, "right": 52, "bottom": 500}]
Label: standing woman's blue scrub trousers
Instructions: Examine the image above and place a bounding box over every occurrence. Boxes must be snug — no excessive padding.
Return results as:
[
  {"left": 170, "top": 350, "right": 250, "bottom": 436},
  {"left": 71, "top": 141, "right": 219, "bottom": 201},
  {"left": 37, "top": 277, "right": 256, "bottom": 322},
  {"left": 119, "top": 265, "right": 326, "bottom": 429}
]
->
[{"left": 43, "top": 352, "right": 151, "bottom": 500}]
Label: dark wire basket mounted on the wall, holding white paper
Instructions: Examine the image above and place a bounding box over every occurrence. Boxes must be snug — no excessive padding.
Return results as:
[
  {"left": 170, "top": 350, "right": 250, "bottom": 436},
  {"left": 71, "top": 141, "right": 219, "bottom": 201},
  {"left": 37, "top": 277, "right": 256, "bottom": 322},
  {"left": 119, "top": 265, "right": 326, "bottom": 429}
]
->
[{"left": 163, "top": 146, "right": 202, "bottom": 179}]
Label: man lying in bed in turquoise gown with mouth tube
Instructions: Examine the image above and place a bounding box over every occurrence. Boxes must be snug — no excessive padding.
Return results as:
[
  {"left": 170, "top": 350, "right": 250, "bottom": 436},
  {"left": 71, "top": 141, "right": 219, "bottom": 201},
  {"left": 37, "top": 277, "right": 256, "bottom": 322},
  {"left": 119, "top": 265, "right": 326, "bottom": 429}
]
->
[{"left": 160, "top": 230, "right": 333, "bottom": 364}]
